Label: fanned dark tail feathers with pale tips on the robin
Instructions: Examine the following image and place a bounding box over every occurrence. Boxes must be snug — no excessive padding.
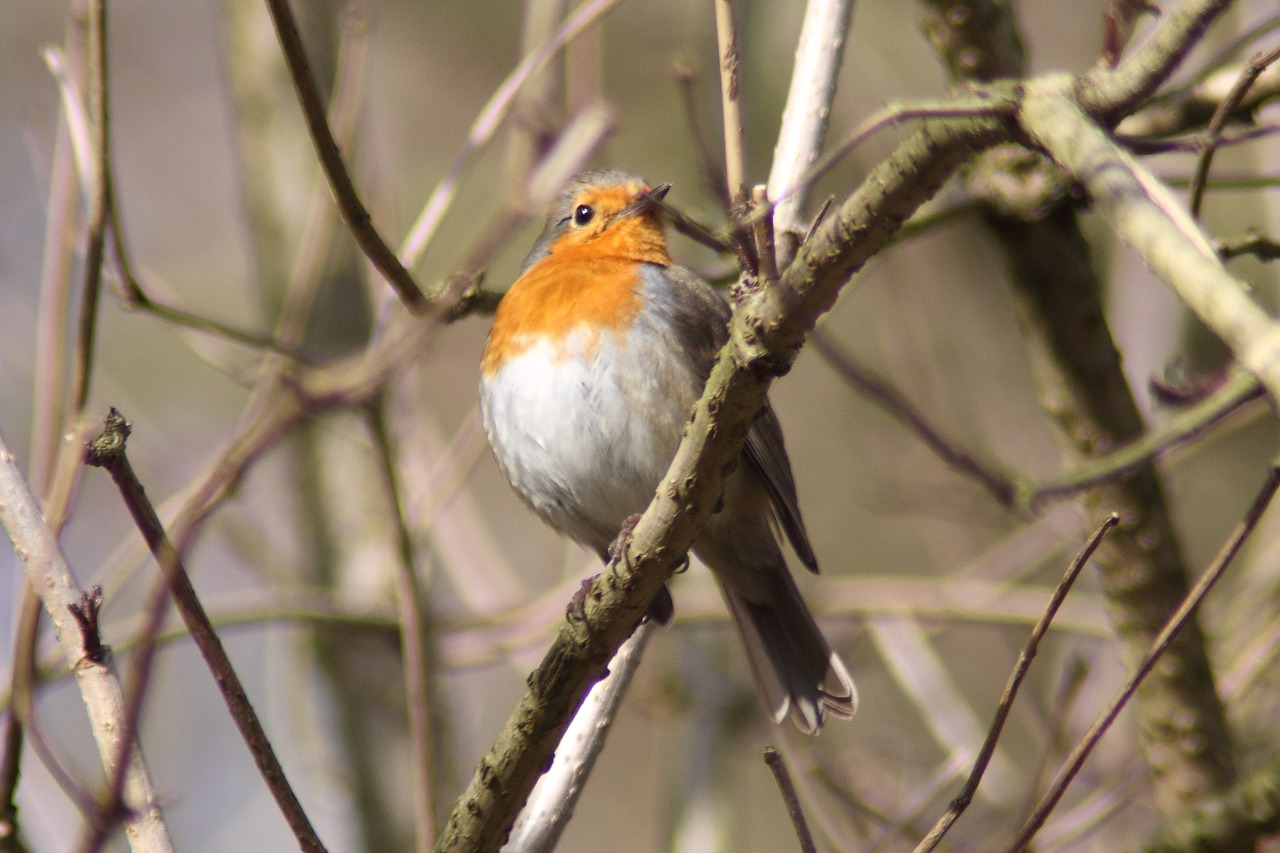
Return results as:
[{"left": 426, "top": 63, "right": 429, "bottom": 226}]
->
[{"left": 721, "top": 567, "right": 858, "bottom": 734}]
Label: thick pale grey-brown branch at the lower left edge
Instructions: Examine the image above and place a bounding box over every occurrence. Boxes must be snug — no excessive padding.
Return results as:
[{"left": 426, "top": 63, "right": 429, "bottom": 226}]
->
[{"left": 0, "top": 427, "right": 173, "bottom": 853}]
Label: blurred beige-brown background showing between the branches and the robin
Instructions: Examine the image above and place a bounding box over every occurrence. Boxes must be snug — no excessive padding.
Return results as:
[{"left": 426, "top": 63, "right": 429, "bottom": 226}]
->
[{"left": 0, "top": 0, "right": 1280, "bottom": 853}]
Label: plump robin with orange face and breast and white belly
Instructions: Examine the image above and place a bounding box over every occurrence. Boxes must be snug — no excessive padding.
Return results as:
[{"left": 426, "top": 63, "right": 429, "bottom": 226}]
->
[{"left": 480, "top": 169, "right": 858, "bottom": 734}]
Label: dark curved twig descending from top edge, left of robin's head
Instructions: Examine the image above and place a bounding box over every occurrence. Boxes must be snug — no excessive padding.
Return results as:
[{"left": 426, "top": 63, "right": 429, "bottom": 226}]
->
[{"left": 266, "top": 0, "right": 429, "bottom": 308}]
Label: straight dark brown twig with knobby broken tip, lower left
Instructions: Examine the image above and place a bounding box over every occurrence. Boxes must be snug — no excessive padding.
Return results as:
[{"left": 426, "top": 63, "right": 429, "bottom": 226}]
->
[{"left": 86, "top": 409, "right": 325, "bottom": 850}]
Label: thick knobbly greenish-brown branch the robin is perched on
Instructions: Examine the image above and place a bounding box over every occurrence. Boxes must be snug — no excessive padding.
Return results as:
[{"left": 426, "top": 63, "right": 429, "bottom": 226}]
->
[{"left": 436, "top": 106, "right": 1004, "bottom": 850}]
